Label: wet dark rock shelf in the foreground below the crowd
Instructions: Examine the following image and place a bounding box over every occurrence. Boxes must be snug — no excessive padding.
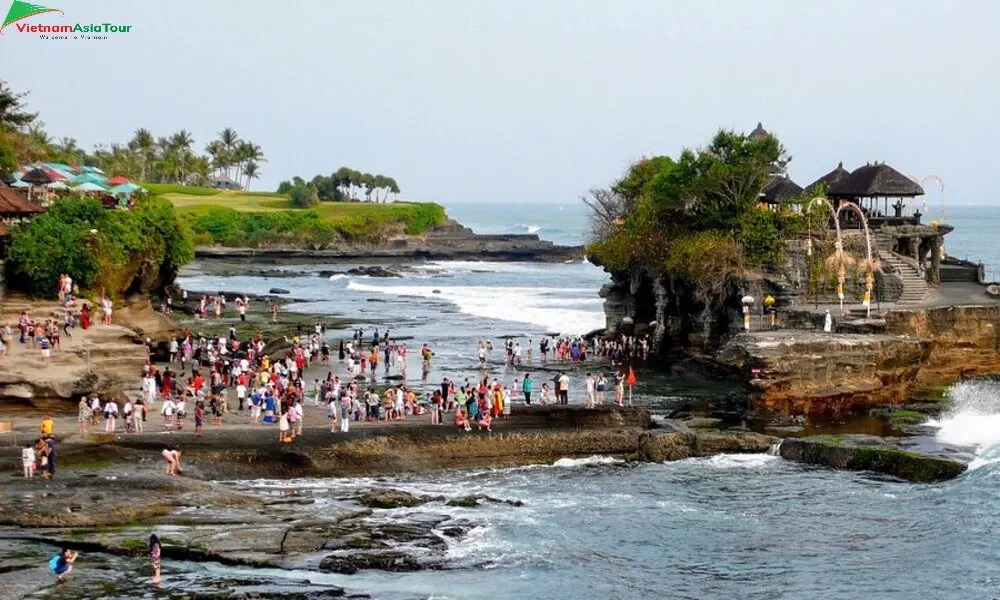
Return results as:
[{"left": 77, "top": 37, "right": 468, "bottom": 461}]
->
[{"left": 0, "top": 407, "right": 965, "bottom": 599}]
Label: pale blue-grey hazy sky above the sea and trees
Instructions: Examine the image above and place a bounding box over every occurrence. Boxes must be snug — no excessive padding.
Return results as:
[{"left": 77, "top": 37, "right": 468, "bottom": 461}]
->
[{"left": 0, "top": 0, "right": 1000, "bottom": 206}]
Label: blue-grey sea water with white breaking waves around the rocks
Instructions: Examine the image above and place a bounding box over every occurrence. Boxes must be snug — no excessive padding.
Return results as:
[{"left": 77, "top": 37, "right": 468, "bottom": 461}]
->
[{"left": 172, "top": 205, "right": 1000, "bottom": 600}]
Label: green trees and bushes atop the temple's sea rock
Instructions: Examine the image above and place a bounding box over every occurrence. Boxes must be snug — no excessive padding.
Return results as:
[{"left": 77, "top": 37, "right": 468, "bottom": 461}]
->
[{"left": 584, "top": 131, "right": 802, "bottom": 298}]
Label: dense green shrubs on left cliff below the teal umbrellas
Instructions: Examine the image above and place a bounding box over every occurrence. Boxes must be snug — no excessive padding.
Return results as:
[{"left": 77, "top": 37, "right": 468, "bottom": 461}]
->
[{"left": 7, "top": 197, "right": 194, "bottom": 297}]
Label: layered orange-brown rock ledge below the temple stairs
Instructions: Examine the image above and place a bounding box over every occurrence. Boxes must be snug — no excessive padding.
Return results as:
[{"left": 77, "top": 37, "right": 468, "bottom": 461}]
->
[{"left": 715, "top": 305, "right": 1000, "bottom": 414}]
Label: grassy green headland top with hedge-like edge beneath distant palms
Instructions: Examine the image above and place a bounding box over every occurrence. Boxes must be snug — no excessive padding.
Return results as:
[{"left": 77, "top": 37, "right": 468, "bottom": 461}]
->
[{"left": 165, "top": 191, "right": 445, "bottom": 249}]
